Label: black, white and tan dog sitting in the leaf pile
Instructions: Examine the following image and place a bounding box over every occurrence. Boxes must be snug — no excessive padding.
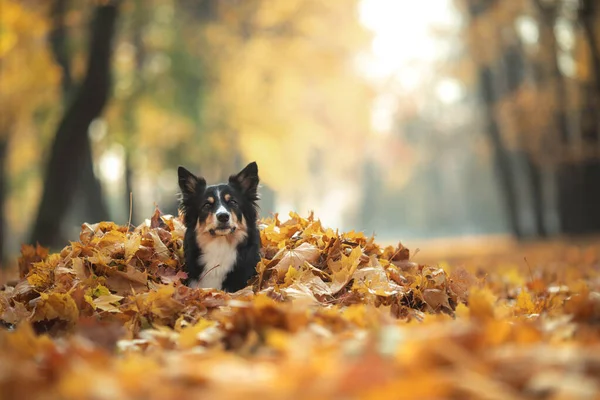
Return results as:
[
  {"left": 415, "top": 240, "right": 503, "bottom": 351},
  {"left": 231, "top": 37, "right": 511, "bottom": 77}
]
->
[{"left": 177, "top": 162, "right": 260, "bottom": 292}]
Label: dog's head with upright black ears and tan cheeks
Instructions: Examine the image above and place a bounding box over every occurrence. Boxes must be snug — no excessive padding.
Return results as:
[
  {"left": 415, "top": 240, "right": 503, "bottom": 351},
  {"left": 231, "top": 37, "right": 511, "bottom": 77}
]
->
[{"left": 178, "top": 162, "right": 259, "bottom": 242}]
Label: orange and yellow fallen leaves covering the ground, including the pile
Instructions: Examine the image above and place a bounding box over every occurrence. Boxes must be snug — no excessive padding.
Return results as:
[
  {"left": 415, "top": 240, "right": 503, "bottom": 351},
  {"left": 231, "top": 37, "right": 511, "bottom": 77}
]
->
[{"left": 0, "top": 211, "right": 600, "bottom": 399}]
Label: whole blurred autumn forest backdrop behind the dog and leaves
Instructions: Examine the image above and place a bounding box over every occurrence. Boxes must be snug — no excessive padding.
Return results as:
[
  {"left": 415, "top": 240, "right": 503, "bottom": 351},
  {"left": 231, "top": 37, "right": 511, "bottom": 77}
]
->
[{"left": 0, "top": 0, "right": 600, "bottom": 265}]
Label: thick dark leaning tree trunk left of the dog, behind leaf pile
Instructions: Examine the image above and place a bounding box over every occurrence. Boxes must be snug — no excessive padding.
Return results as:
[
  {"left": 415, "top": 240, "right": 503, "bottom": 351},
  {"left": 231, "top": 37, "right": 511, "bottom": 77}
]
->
[{"left": 31, "top": 2, "right": 118, "bottom": 246}]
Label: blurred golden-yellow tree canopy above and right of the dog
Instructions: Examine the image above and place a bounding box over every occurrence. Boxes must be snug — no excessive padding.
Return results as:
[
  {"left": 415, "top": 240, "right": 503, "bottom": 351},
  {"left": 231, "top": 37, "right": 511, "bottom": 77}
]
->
[{"left": 203, "top": 0, "right": 370, "bottom": 193}]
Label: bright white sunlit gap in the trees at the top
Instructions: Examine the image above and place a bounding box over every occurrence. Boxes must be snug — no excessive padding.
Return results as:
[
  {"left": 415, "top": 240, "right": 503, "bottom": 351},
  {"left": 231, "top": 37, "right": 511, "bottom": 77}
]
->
[{"left": 359, "top": 0, "right": 463, "bottom": 134}]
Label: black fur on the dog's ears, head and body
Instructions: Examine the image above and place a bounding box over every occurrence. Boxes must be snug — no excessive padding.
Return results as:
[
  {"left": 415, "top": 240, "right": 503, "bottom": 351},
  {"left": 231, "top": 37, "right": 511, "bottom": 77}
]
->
[{"left": 178, "top": 162, "right": 260, "bottom": 292}]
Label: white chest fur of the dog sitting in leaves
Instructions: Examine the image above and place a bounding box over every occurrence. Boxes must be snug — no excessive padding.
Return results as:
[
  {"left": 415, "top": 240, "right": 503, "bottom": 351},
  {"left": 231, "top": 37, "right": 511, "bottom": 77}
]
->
[{"left": 194, "top": 238, "right": 237, "bottom": 290}]
